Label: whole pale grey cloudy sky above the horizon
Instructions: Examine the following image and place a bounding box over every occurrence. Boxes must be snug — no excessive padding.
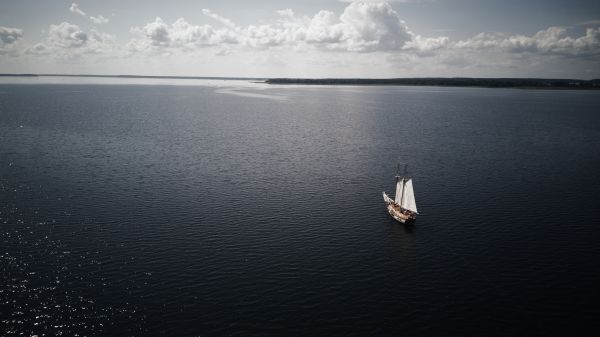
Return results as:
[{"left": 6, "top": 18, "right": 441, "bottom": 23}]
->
[{"left": 0, "top": 0, "right": 600, "bottom": 79}]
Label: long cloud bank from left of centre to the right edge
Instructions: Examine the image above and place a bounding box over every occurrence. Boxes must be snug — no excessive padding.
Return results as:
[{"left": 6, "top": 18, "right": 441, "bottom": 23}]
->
[{"left": 123, "top": 2, "right": 600, "bottom": 57}]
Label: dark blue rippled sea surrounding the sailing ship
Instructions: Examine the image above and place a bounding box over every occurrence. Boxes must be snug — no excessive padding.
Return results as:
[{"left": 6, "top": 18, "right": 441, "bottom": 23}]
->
[{"left": 0, "top": 80, "right": 600, "bottom": 336}]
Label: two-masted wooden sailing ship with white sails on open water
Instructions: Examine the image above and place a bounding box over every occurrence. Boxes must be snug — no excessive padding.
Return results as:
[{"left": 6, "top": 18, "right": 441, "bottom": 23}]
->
[{"left": 383, "top": 164, "right": 419, "bottom": 224}]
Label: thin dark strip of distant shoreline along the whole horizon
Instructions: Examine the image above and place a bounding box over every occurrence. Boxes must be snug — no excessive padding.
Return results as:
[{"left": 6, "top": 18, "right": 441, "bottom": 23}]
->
[{"left": 0, "top": 74, "right": 600, "bottom": 90}]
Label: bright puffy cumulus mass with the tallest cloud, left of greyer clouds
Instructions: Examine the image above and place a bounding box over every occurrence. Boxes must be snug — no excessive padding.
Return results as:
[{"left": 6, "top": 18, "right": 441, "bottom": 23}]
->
[{"left": 130, "top": 3, "right": 413, "bottom": 52}]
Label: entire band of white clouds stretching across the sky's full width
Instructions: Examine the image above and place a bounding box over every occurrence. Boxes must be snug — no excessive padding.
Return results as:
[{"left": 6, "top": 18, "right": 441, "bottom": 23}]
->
[{"left": 0, "top": 1, "right": 600, "bottom": 76}]
